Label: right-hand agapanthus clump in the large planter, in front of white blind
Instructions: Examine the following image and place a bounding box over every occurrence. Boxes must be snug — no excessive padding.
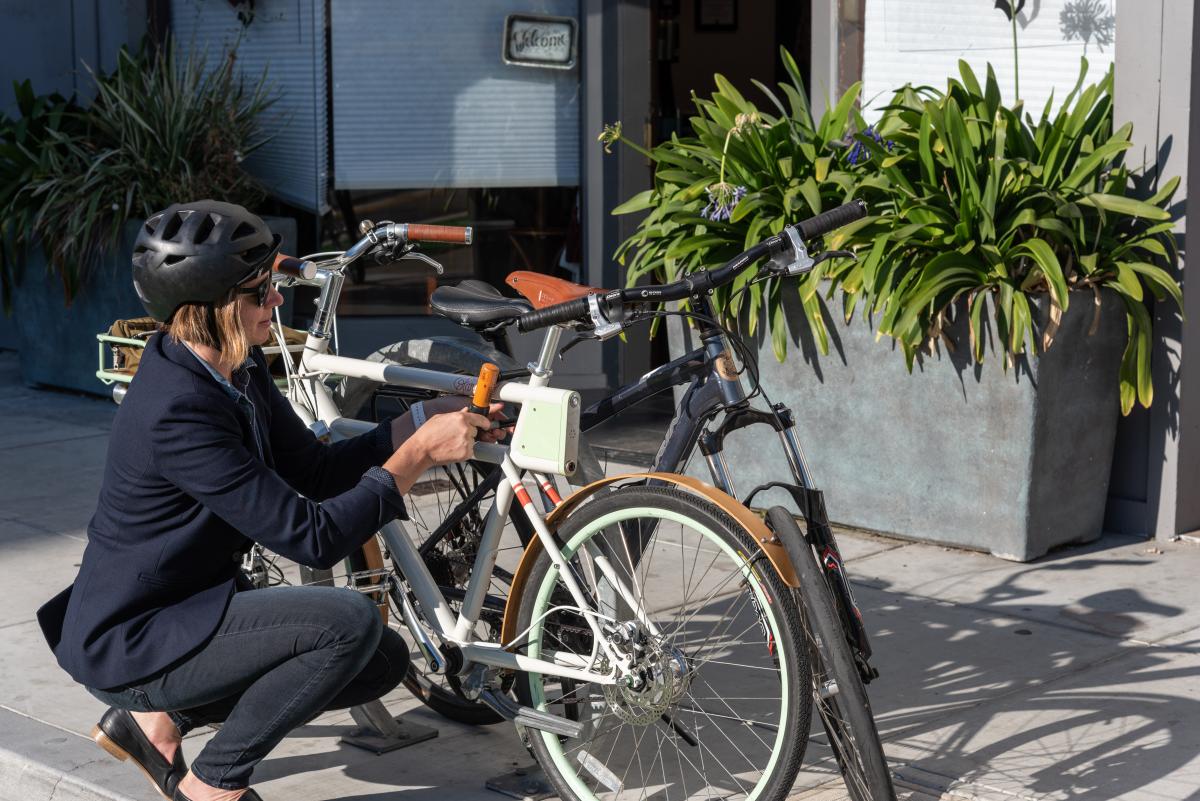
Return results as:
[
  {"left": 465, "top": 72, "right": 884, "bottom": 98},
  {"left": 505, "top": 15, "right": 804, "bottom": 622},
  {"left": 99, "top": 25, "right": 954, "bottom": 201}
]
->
[{"left": 832, "top": 61, "right": 1182, "bottom": 412}]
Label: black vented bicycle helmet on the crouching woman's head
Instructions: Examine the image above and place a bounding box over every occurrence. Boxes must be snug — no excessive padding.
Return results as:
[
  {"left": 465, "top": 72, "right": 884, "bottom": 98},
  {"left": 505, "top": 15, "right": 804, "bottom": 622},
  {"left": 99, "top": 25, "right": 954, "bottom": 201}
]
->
[{"left": 133, "top": 200, "right": 280, "bottom": 323}]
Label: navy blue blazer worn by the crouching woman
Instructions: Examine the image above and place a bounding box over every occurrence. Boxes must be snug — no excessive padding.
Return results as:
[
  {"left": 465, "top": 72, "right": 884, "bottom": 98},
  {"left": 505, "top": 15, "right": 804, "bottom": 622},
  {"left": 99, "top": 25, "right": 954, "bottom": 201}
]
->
[{"left": 37, "top": 335, "right": 404, "bottom": 689}]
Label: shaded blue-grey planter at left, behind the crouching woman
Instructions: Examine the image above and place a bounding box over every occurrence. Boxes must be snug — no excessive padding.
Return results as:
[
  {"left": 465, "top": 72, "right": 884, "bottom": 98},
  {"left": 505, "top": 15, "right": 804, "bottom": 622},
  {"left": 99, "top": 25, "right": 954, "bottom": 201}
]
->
[{"left": 12, "top": 217, "right": 296, "bottom": 395}]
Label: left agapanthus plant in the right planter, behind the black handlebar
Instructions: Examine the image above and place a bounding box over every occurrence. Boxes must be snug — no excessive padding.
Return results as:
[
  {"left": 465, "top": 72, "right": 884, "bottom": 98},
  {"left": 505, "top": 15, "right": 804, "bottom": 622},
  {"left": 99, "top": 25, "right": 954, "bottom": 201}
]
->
[{"left": 600, "top": 50, "right": 862, "bottom": 359}]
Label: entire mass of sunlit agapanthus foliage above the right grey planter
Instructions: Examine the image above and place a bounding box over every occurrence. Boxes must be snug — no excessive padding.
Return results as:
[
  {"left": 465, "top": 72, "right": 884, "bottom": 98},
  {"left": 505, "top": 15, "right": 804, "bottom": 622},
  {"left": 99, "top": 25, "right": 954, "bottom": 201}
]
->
[{"left": 601, "top": 52, "right": 1182, "bottom": 412}]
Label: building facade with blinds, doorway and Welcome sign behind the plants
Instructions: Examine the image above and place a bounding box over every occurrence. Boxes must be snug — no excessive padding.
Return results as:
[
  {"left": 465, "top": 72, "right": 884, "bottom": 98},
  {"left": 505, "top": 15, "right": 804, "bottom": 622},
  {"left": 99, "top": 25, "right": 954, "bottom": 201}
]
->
[{"left": 0, "top": 0, "right": 1200, "bottom": 537}]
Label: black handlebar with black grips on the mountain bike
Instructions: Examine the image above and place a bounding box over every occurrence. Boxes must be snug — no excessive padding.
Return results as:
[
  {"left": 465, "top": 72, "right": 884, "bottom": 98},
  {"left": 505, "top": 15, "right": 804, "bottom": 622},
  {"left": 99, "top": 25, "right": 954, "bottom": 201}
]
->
[{"left": 517, "top": 200, "right": 866, "bottom": 332}]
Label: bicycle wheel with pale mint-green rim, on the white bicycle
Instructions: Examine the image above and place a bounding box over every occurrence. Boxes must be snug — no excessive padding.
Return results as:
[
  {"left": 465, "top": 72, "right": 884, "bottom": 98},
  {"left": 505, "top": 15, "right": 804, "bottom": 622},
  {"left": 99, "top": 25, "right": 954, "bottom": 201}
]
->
[{"left": 516, "top": 486, "right": 811, "bottom": 801}]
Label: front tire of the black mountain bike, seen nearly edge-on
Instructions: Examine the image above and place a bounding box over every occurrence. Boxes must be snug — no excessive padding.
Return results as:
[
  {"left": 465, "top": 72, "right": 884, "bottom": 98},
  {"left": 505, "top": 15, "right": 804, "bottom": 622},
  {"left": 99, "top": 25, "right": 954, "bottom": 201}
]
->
[{"left": 767, "top": 506, "right": 896, "bottom": 801}]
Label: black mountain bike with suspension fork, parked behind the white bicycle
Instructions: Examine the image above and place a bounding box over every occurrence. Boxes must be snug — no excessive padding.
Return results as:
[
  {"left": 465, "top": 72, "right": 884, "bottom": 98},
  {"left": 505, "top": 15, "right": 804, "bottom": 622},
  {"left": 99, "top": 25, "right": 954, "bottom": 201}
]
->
[{"left": 342, "top": 196, "right": 895, "bottom": 801}]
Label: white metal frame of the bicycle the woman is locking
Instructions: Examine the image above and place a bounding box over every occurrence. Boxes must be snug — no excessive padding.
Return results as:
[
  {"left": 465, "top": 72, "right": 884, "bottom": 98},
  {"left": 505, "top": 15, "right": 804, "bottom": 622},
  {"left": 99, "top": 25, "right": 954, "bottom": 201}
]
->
[{"left": 274, "top": 263, "right": 659, "bottom": 685}]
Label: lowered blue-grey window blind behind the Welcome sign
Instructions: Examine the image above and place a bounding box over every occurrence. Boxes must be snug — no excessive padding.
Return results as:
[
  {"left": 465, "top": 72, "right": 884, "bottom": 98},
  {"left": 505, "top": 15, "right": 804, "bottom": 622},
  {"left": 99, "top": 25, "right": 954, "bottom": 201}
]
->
[{"left": 331, "top": 0, "right": 580, "bottom": 189}]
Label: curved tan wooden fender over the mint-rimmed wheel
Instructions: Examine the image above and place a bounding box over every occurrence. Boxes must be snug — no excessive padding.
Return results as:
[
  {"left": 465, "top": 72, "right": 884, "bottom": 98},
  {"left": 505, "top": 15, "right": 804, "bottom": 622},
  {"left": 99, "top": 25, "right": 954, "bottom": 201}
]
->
[{"left": 500, "top": 472, "right": 800, "bottom": 643}]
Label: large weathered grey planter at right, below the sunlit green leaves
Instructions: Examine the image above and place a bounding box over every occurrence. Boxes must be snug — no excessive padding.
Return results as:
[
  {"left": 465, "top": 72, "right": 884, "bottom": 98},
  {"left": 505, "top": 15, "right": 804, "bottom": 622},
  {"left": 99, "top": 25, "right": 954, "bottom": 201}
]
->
[{"left": 670, "top": 290, "right": 1126, "bottom": 561}]
